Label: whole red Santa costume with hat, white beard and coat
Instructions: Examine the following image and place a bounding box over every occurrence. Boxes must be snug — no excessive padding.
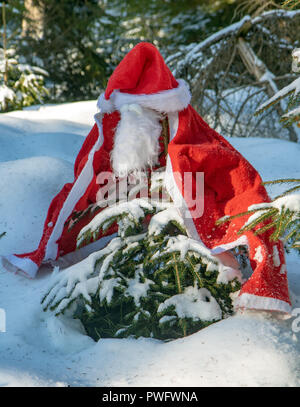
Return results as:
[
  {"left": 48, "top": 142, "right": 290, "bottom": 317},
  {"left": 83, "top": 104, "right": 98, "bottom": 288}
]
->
[{"left": 2, "top": 43, "right": 291, "bottom": 312}]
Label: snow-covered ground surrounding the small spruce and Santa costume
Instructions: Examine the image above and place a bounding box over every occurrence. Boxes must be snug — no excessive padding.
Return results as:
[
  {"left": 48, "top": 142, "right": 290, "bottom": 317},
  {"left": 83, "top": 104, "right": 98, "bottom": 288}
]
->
[{"left": 0, "top": 101, "right": 300, "bottom": 386}]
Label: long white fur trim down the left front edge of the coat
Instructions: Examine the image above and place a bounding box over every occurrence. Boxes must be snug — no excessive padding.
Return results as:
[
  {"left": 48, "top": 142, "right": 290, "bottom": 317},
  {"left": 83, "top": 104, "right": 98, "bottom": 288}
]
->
[{"left": 44, "top": 114, "right": 104, "bottom": 260}]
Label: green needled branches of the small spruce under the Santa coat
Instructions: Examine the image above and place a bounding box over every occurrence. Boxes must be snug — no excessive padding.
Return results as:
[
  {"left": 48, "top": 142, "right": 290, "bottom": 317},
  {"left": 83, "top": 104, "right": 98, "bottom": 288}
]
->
[{"left": 42, "top": 193, "right": 240, "bottom": 341}]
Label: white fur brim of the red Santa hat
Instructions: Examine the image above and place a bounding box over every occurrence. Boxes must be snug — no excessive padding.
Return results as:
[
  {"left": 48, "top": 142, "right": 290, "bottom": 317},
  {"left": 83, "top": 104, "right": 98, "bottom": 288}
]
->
[{"left": 97, "top": 79, "right": 191, "bottom": 113}]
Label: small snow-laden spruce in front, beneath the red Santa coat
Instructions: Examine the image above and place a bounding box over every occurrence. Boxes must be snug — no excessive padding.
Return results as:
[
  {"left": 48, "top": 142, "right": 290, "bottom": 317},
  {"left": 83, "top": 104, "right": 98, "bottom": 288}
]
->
[{"left": 42, "top": 187, "right": 240, "bottom": 340}]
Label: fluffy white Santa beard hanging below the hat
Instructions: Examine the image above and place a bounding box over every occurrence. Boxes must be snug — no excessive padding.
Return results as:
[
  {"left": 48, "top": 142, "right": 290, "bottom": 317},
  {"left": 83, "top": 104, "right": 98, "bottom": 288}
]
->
[{"left": 111, "top": 104, "right": 161, "bottom": 177}]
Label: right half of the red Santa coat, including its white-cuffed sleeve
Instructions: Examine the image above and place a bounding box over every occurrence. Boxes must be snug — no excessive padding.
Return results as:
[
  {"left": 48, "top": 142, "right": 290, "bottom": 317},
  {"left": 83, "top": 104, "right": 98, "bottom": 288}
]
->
[{"left": 167, "top": 106, "right": 291, "bottom": 312}]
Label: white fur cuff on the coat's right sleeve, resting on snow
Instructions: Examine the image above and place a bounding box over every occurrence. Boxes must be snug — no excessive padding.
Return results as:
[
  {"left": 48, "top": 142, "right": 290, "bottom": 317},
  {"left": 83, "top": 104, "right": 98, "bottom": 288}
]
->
[{"left": 234, "top": 293, "right": 292, "bottom": 314}]
